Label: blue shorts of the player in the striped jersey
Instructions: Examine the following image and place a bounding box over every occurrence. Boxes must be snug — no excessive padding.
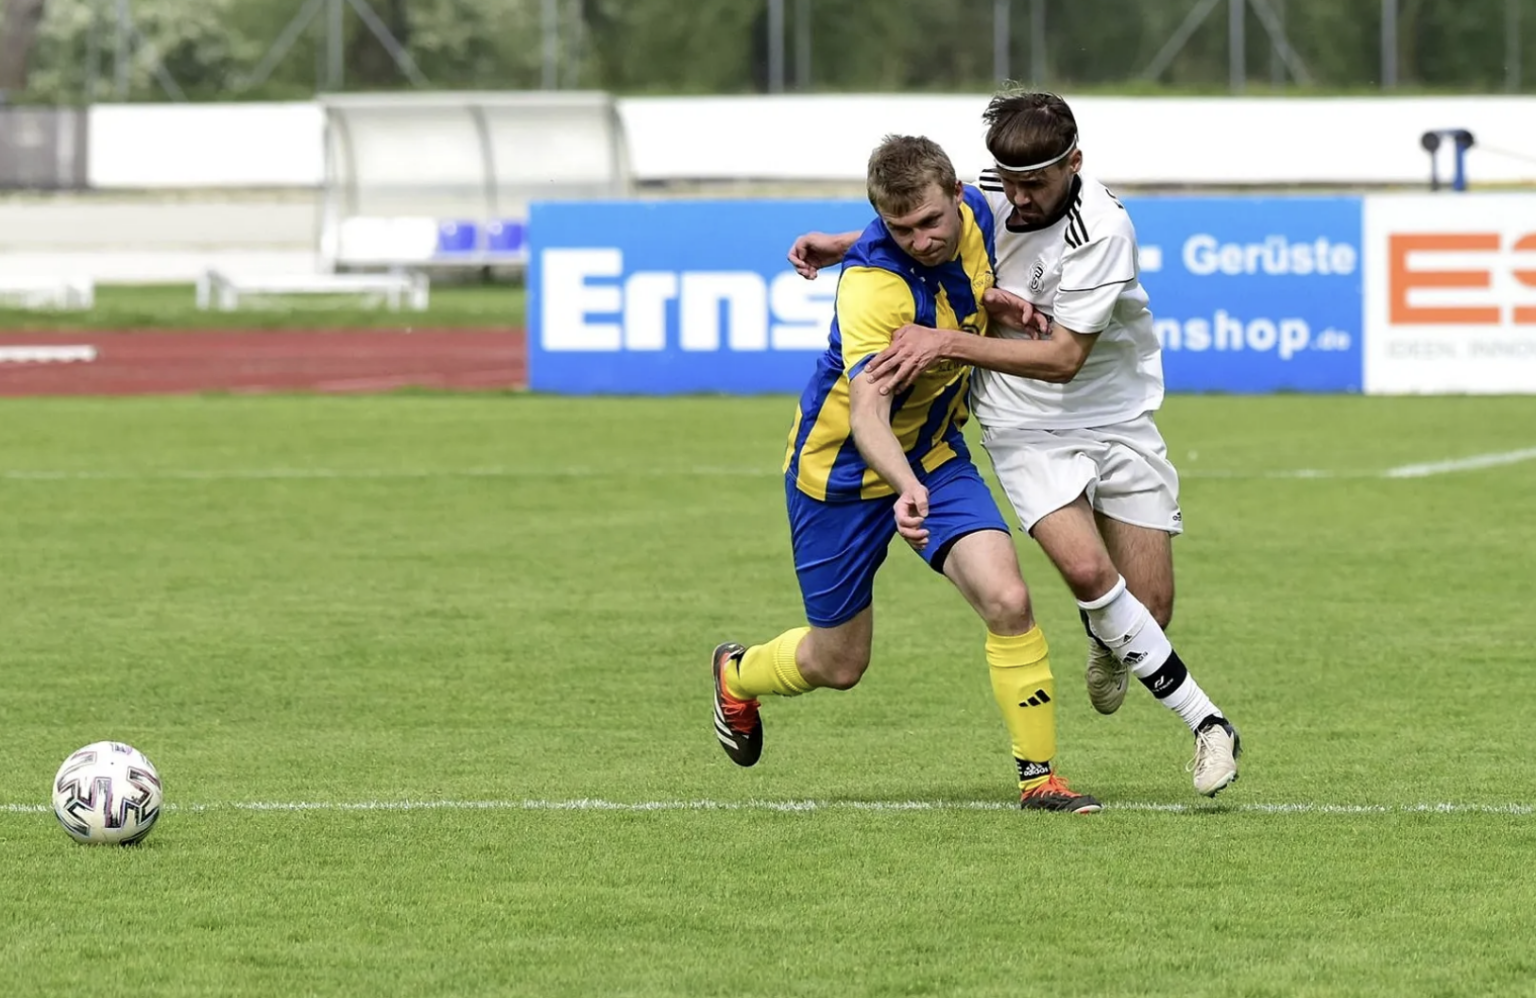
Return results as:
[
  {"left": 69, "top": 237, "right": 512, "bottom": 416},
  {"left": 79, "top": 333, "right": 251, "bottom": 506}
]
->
[{"left": 783, "top": 458, "right": 1008, "bottom": 628}]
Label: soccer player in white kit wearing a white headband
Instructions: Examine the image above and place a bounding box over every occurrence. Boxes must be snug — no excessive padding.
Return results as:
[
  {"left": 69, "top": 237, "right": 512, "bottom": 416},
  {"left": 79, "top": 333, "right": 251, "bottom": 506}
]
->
[{"left": 790, "top": 94, "right": 1241, "bottom": 797}]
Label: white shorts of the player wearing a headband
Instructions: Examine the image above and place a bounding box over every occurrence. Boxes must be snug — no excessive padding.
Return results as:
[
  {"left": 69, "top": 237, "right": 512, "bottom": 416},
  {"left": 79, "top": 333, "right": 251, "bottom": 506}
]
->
[{"left": 982, "top": 413, "right": 1184, "bottom": 534}]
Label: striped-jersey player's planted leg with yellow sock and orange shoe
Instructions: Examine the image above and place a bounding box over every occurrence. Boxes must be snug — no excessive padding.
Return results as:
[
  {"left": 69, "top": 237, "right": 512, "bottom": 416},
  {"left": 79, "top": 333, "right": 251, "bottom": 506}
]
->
[{"left": 943, "top": 530, "right": 1101, "bottom": 814}]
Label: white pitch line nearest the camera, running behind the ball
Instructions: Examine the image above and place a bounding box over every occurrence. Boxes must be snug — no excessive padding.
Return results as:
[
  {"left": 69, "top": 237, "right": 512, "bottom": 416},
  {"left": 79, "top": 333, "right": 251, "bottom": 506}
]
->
[{"left": 0, "top": 797, "right": 1536, "bottom": 817}]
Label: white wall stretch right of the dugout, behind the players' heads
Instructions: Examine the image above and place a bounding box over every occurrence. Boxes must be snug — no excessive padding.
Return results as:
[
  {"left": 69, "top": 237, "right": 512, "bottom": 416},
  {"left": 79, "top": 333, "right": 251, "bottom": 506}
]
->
[{"left": 619, "top": 95, "right": 1536, "bottom": 187}]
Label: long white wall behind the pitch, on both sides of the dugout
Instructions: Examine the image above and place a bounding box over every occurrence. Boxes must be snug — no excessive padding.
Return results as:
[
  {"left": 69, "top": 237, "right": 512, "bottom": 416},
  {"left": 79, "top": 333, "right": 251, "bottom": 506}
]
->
[{"left": 77, "top": 95, "right": 1536, "bottom": 189}]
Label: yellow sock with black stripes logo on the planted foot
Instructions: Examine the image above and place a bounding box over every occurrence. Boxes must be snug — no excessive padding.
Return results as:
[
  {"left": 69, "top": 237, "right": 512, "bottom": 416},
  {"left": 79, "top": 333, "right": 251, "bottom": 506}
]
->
[{"left": 986, "top": 626, "right": 1055, "bottom": 791}]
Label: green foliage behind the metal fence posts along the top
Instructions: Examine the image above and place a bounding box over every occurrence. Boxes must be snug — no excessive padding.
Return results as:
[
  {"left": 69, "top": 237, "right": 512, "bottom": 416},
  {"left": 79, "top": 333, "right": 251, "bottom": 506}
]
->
[{"left": 12, "top": 0, "right": 1536, "bottom": 101}]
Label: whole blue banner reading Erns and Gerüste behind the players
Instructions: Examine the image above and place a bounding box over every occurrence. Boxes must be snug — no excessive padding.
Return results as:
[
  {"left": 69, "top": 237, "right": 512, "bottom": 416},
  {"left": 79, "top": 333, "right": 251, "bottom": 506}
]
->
[{"left": 528, "top": 198, "right": 1362, "bottom": 395}]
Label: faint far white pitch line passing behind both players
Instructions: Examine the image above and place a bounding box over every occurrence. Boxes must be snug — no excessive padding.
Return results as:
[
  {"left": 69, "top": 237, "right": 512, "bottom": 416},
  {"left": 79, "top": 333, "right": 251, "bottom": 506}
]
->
[{"left": 0, "top": 447, "right": 1536, "bottom": 482}]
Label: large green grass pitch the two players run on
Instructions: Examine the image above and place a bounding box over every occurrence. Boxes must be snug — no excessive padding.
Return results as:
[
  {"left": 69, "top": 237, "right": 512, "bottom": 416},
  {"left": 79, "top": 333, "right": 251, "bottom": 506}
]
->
[{"left": 0, "top": 395, "right": 1536, "bottom": 998}]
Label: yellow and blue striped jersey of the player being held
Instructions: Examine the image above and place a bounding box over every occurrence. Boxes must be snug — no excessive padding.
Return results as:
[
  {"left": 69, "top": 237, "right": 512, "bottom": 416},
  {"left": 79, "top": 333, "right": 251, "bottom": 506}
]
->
[{"left": 783, "top": 186, "right": 995, "bottom": 502}]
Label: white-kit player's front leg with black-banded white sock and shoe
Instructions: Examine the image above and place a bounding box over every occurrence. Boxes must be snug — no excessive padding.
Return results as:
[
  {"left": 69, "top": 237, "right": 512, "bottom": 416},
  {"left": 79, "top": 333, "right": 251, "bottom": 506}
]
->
[{"left": 1031, "top": 496, "right": 1241, "bottom": 795}]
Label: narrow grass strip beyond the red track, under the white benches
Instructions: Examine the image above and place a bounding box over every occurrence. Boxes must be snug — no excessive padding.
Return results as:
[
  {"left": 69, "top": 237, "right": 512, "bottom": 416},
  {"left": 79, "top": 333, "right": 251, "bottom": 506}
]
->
[{"left": 0, "top": 284, "right": 524, "bottom": 332}]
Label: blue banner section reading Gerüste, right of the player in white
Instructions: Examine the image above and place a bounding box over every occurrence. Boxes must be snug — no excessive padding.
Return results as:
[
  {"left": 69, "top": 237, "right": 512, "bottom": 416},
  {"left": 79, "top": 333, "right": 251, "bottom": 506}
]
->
[{"left": 1126, "top": 198, "right": 1364, "bottom": 393}]
